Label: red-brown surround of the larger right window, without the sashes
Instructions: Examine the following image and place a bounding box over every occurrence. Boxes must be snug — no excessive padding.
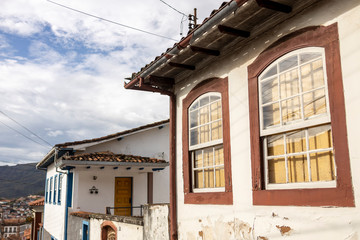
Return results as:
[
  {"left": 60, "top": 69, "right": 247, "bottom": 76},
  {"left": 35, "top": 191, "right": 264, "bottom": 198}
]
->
[{"left": 248, "top": 23, "right": 355, "bottom": 207}]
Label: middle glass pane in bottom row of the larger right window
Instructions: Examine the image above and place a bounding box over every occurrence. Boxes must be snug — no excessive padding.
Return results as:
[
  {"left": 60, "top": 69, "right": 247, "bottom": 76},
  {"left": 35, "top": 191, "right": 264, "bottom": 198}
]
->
[{"left": 288, "top": 155, "right": 309, "bottom": 182}]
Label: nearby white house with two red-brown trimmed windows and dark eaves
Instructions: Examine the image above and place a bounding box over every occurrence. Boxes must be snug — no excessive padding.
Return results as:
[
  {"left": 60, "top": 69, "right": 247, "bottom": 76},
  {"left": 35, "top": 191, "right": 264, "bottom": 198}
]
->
[{"left": 125, "top": 0, "right": 360, "bottom": 239}]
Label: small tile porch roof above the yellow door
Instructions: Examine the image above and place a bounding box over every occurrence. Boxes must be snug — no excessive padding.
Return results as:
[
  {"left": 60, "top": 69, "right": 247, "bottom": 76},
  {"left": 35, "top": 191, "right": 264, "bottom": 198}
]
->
[{"left": 64, "top": 152, "right": 166, "bottom": 163}]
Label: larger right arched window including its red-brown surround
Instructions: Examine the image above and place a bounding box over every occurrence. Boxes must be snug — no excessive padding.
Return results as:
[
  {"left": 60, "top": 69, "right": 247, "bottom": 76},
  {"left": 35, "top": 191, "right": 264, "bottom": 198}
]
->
[{"left": 248, "top": 24, "right": 354, "bottom": 206}]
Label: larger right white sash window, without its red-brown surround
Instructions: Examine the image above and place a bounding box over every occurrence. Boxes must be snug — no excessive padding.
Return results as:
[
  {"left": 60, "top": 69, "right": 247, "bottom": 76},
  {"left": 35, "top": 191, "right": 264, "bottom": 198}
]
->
[{"left": 258, "top": 47, "right": 336, "bottom": 189}]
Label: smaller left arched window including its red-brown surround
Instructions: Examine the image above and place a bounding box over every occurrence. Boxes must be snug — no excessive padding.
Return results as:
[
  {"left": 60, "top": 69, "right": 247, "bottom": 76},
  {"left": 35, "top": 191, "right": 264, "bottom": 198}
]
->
[{"left": 183, "top": 78, "right": 232, "bottom": 204}]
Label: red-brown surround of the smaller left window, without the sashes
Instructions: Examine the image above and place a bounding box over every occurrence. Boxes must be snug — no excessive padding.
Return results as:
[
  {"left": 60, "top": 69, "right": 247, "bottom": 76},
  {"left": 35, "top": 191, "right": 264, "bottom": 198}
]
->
[{"left": 182, "top": 78, "right": 233, "bottom": 205}]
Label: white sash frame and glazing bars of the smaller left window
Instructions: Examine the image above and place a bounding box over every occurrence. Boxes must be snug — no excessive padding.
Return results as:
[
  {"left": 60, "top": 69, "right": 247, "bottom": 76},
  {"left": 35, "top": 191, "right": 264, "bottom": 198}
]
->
[{"left": 187, "top": 92, "right": 225, "bottom": 193}]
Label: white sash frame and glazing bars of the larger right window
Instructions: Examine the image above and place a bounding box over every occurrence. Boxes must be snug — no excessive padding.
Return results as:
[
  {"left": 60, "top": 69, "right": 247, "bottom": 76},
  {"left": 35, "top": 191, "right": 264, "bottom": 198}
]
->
[{"left": 258, "top": 47, "right": 336, "bottom": 190}]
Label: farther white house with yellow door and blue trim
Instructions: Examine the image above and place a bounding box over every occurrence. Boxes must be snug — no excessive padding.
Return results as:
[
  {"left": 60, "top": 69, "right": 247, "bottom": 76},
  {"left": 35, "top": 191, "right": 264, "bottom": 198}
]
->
[{"left": 36, "top": 120, "right": 169, "bottom": 240}]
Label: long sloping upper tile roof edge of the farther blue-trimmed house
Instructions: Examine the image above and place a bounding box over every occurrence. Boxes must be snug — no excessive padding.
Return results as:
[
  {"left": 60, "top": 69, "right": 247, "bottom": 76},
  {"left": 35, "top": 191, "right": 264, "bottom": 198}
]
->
[{"left": 55, "top": 119, "right": 169, "bottom": 147}]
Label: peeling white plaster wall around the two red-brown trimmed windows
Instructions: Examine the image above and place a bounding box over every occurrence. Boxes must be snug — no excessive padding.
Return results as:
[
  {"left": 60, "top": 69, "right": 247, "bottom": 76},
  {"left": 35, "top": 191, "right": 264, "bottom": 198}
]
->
[{"left": 175, "top": 0, "right": 360, "bottom": 240}]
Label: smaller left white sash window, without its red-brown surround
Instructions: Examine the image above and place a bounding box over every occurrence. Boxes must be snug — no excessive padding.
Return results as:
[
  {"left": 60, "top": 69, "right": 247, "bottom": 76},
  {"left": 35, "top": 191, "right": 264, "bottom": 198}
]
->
[{"left": 188, "top": 92, "right": 225, "bottom": 192}]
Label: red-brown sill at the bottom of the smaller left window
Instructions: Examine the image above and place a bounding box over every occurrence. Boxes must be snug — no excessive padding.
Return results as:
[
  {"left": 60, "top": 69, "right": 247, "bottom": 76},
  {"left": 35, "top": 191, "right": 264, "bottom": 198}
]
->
[{"left": 184, "top": 192, "right": 233, "bottom": 205}]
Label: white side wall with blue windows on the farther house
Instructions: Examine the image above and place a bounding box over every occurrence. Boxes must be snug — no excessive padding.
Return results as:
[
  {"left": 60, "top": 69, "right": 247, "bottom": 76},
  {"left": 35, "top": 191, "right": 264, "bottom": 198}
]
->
[{"left": 44, "top": 164, "right": 67, "bottom": 240}]
